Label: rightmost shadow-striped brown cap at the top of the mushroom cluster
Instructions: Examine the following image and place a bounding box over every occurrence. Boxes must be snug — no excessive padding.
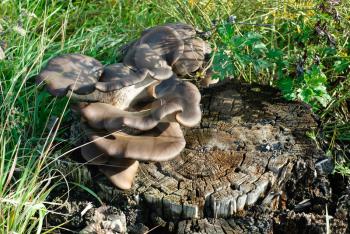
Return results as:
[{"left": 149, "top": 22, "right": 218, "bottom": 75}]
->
[{"left": 173, "top": 38, "right": 210, "bottom": 76}]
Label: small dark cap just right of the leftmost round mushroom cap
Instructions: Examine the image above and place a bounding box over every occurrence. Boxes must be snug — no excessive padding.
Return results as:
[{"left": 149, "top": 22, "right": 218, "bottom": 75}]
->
[{"left": 95, "top": 63, "right": 148, "bottom": 92}]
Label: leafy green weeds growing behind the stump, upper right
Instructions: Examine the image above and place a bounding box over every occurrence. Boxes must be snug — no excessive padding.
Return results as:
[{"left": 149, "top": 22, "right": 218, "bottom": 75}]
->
[{"left": 209, "top": 0, "right": 350, "bottom": 175}]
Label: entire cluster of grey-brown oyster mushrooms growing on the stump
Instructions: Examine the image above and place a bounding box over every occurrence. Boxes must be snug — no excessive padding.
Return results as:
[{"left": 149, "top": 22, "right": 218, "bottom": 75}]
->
[{"left": 37, "top": 23, "right": 211, "bottom": 189}]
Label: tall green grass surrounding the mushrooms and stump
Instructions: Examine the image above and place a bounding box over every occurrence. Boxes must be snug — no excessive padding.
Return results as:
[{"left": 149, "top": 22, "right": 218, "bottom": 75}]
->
[{"left": 0, "top": 0, "right": 350, "bottom": 233}]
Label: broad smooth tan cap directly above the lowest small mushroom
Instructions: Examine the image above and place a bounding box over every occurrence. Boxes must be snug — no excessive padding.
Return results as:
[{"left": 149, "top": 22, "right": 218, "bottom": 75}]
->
[{"left": 83, "top": 123, "right": 186, "bottom": 161}]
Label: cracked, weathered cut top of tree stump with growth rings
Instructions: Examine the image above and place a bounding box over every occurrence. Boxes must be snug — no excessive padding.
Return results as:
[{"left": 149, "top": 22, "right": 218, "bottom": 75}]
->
[{"left": 132, "top": 81, "right": 323, "bottom": 220}]
